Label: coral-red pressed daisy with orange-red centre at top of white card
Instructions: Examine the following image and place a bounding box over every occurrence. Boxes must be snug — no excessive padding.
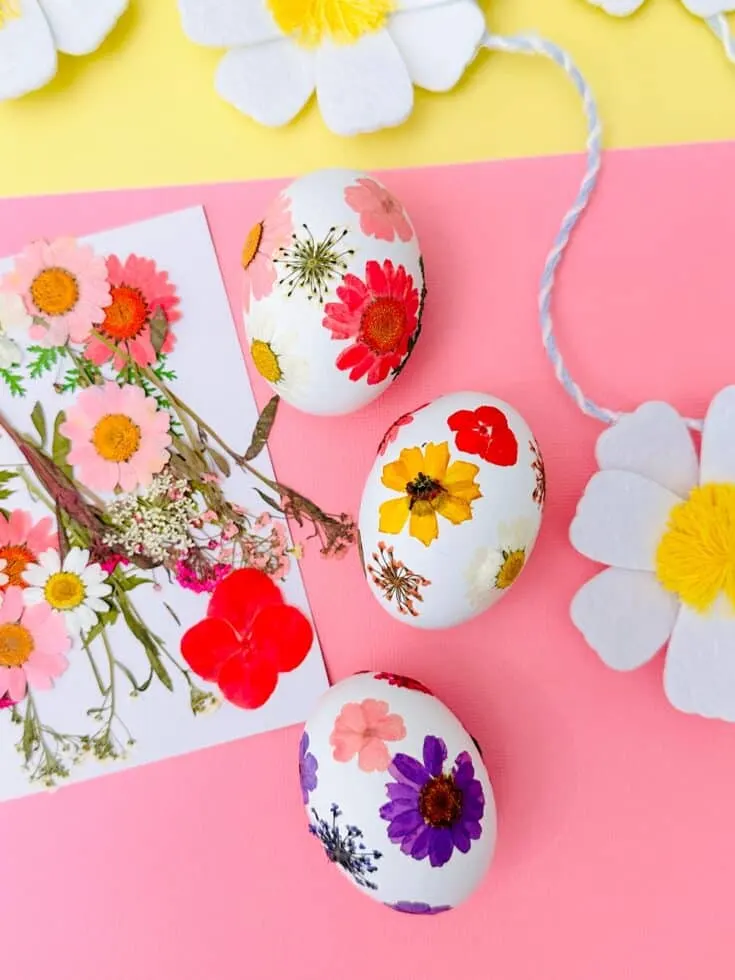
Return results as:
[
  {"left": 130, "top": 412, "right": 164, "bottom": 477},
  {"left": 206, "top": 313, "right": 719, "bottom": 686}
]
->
[{"left": 84, "top": 255, "right": 181, "bottom": 371}]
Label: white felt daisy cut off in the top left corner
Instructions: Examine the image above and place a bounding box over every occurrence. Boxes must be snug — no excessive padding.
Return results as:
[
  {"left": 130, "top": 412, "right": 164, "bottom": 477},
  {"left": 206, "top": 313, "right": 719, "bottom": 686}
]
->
[{"left": 0, "top": 0, "right": 128, "bottom": 101}]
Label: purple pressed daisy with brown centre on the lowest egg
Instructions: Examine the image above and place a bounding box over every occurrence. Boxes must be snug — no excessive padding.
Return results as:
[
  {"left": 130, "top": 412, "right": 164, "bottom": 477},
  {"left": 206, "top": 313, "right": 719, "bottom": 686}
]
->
[{"left": 380, "top": 735, "right": 485, "bottom": 868}]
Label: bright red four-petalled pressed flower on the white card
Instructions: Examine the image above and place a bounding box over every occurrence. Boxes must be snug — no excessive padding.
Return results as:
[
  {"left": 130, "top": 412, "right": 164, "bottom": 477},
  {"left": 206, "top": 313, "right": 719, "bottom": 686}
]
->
[{"left": 181, "top": 568, "right": 314, "bottom": 708}]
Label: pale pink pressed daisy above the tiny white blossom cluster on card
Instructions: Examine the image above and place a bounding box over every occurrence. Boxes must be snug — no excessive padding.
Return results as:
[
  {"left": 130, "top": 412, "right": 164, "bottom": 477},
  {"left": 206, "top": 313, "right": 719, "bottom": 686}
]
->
[{"left": 60, "top": 381, "right": 171, "bottom": 493}]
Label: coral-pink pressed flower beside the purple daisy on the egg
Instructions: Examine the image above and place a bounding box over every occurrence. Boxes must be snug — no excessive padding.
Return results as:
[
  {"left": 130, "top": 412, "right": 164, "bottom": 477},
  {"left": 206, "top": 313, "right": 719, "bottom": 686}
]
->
[{"left": 329, "top": 698, "right": 406, "bottom": 772}]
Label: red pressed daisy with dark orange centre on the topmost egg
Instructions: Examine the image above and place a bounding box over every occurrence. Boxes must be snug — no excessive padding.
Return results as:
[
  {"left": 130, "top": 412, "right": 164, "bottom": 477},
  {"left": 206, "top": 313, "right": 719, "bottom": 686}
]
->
[{"left": 324, "top": 260, "right": 420, "bottom": 385}]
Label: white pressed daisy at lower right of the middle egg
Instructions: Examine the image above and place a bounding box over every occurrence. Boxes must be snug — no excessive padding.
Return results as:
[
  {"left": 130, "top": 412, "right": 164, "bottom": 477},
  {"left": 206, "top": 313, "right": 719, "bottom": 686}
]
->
[{"left": 465, "top": 518, "right": 538, "bottom": 610}]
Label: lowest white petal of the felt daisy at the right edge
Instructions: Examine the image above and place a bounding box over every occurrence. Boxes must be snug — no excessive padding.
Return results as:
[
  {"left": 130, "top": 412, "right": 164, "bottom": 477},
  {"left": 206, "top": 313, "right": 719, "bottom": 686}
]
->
[{"left": 664, "top": 607, "right": 735, "bottom": 721}]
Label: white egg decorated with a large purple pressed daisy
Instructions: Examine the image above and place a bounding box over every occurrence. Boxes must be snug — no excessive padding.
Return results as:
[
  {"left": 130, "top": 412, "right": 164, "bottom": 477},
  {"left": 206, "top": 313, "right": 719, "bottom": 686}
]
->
[{"left": 299, "top": 673, "right": 497, "bottom": 915}]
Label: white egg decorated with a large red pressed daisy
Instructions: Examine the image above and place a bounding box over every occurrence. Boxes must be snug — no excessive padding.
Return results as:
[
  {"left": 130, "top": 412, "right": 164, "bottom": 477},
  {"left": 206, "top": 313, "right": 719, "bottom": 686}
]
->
[{"left": 242, "top": 170, "right": 424, "bottom": 415}]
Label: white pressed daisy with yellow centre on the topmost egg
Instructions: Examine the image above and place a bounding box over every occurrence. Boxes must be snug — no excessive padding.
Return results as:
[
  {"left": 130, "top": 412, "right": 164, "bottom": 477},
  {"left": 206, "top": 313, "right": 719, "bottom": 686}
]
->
[{"left": 245, "top": 306, "right": 309, "bottom": 403}]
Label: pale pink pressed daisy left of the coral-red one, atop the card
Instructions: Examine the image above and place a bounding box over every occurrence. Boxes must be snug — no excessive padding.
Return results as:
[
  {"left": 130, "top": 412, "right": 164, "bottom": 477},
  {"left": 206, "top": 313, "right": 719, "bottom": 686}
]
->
[{"left": 0, "top": 238, "right": 110, "bottom": 347}]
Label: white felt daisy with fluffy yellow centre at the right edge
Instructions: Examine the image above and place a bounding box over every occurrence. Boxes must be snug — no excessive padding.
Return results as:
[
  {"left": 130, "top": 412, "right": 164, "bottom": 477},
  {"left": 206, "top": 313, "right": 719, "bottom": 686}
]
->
[{"left": 570, "top": 387, "right": 735, "bottom": 721}]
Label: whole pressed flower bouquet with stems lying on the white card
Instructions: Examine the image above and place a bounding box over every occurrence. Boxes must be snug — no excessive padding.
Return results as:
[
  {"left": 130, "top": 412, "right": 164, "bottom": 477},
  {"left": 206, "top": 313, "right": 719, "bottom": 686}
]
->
[{"left": 0, "top": 218, "right": 355, "bottom": 786}]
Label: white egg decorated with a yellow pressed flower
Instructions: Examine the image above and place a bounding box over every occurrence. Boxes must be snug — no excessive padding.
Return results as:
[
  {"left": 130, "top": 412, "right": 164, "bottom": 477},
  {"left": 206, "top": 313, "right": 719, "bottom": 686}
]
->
[{"left": 359, "top": 391, "right": 546, "bottom": 629}]
